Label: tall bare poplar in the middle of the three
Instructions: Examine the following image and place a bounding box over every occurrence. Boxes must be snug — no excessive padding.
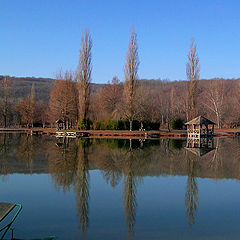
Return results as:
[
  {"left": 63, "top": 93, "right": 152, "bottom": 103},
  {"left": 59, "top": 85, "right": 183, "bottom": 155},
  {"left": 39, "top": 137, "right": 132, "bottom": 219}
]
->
[{"left": 124, "top": 28, "right": 139, "bottom": 131}]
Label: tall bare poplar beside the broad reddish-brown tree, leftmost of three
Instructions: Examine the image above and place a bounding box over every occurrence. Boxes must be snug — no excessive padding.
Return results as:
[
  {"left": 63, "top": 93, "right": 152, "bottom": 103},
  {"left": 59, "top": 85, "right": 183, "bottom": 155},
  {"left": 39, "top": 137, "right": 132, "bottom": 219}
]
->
[{"left": 76, "top": 29, "right": 92, "bottom": 128}]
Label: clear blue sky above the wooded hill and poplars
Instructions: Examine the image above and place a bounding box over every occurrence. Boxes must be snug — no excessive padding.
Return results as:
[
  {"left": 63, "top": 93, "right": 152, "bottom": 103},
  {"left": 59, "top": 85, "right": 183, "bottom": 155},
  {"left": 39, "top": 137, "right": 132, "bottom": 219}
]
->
[{"left": 0, "top": 0, "right": 240, "bottom": 83}]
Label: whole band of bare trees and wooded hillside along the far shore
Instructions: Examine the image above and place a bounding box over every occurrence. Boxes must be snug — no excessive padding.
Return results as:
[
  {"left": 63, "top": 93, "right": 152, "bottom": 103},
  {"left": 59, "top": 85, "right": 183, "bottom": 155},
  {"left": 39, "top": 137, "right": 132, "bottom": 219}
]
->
[{"left": 0, "top": 29, "right": 240, "bottom": 130}]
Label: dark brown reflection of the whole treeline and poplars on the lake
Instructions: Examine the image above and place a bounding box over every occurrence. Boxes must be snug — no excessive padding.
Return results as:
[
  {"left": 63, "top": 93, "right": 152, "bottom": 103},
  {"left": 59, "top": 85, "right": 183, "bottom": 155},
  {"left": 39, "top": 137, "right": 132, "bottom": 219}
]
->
[{"left": 0, "top": 134, "right": 240, "bottom": 239}]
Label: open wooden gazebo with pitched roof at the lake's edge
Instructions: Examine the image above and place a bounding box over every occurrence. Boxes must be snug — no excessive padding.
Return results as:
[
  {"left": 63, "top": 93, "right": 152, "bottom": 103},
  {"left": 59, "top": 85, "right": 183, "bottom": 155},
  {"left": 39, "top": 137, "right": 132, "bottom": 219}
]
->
[{"left": 185, "top": 116, "right": 215, "bottom": 139}]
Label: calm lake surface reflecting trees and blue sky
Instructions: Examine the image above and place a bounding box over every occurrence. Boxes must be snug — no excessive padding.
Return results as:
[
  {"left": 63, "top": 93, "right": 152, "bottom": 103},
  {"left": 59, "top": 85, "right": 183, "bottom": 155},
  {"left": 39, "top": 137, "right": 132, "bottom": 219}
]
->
[{"left": 0, "top": 134, "right": 240, "bottom": 240}]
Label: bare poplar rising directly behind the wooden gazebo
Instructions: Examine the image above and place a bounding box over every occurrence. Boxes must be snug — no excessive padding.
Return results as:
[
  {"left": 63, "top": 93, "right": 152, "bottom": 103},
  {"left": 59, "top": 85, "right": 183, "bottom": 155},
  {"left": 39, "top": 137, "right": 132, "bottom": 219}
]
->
[{"left": 186, "top": 40, "right": 200, "bottom": 118}]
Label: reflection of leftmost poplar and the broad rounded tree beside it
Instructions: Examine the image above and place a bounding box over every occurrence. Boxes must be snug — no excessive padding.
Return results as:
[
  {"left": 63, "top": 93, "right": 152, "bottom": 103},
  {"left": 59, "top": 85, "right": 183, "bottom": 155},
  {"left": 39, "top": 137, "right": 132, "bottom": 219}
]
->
[{"left": 48, "top": 138, "right": 89, "bottom": 237}]
